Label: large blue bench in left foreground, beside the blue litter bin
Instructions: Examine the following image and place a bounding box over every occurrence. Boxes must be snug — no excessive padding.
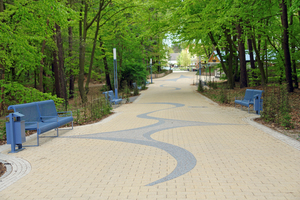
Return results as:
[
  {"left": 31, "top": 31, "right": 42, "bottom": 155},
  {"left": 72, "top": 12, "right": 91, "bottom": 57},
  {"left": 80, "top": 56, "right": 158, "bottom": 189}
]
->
[{"left": 8, "top": 100, "right": 73, "bottom": 146}]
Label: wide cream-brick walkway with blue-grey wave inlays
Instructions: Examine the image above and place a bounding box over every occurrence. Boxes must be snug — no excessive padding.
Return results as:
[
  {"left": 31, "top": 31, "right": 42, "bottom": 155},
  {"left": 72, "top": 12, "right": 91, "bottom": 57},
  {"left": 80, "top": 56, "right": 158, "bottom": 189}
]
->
[{"left": 0, "top": 73, "right": 300, "bottom": 200}]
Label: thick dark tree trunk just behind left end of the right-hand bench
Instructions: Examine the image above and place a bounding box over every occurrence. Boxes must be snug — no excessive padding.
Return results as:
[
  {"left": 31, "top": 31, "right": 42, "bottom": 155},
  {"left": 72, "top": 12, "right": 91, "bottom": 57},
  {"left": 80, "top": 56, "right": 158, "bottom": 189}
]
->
[{"left": 236, "top": 24, "right": 248, "bottom": 88}]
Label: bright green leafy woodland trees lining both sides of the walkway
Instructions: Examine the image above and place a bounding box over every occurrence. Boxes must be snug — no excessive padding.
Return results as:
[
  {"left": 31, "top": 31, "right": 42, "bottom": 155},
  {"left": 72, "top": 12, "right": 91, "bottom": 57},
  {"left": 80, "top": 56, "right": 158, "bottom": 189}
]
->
[{"left": 0, "top": 0, "right": 300, "bottom": 110}]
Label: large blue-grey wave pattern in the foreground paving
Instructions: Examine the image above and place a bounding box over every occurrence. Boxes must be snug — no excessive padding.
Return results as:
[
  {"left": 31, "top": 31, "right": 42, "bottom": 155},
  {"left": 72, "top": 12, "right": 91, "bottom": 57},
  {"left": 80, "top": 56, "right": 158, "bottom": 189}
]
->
[{"left": 66, "top": 102, "right": 234, "bottom": 186}]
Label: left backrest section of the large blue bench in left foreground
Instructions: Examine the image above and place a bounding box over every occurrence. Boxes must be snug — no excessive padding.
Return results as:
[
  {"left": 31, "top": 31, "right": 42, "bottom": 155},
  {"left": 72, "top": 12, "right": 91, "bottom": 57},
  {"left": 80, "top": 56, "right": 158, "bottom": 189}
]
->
[{"left": 8, "top": 102, "right": 41, "bottom": 122}]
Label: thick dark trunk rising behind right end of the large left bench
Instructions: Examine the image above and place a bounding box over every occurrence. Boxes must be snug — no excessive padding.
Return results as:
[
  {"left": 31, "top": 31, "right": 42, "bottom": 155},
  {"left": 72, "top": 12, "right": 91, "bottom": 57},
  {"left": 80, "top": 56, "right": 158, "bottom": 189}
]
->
[{"left": 55, "top": 24, "right": 68, "bottom": 105}]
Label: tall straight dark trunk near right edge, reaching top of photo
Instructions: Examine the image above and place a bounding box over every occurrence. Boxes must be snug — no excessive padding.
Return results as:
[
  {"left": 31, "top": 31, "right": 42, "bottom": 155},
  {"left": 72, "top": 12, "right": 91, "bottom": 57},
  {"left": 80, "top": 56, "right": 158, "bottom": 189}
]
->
[{"left": 281, "top": 0, "right": 294, "bottom": 92}]
